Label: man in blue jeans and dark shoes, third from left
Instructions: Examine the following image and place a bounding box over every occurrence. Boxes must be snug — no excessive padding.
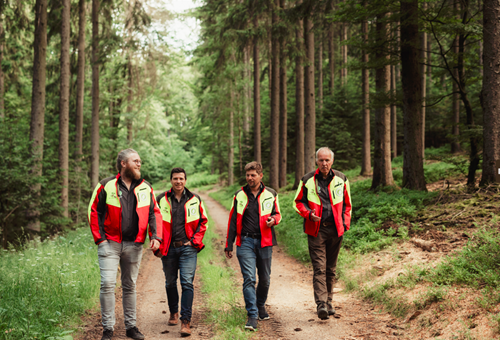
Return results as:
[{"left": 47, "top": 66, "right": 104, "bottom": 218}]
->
[{"left": 224, "top": 162, "right": 281, "bottom": 331}]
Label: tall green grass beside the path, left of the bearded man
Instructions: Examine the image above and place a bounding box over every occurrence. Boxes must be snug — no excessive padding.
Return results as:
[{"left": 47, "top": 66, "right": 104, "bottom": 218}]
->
[{"left": 0, "top": 228, "right": 100, "bottom": 340}]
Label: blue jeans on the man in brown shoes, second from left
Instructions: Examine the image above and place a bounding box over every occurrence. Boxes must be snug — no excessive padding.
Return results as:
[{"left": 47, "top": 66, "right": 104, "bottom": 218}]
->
[{"left": 161, "top": 245, "right": 198, "bottom": 321}]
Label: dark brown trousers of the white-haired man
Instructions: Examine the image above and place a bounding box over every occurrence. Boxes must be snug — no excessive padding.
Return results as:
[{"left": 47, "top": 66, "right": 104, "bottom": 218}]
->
[{"left": 307, "top": 226, "right": 343, "bottom": 305}]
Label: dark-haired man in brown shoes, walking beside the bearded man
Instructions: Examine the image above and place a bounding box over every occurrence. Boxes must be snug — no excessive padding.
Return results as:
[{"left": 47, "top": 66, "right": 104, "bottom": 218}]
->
[{"left": 156, "top": 168, "right": 208, "bottom": 336}]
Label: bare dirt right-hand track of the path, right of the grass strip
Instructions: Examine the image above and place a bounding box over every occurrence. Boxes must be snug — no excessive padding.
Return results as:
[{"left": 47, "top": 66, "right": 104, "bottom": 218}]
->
[{"left": 200, "top": 194, "right": 402, "bottom": 340}]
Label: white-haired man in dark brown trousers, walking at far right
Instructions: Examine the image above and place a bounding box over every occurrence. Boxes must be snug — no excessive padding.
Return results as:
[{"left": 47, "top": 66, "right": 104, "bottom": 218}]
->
[{"left": 294, "top": 147, "right": 351, "bottom": 320}]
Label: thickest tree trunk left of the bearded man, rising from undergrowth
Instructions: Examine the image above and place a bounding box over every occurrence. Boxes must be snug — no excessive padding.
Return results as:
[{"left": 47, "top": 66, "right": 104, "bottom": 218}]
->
[{"left": 26, "top": 0, "right": 47, "bottom": 231}]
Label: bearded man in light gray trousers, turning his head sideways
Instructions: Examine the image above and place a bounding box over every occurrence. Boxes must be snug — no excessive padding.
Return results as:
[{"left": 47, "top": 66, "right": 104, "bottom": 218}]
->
[{"left": 88, "top": 149, "right": 162, "bottom": 340}]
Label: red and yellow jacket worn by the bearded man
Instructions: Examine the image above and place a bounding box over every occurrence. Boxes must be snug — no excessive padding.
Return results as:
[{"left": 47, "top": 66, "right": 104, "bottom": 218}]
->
[{"left": 88, "top": 174, "right": 162, "bottom": 244}]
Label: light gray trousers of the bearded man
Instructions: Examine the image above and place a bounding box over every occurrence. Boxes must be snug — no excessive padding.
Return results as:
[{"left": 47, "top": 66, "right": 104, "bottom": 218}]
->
[{"left": 97, "top": 241, "right": 142, "bottom": 330}]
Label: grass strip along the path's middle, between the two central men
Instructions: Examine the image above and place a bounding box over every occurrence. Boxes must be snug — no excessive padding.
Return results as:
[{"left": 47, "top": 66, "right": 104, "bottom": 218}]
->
[{"left": 198, "top": 211, "right": 253, "bottom": 339}]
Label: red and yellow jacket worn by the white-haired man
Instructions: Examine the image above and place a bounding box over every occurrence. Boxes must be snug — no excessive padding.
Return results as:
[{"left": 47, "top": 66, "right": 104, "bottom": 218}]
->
[{"left": 294, "top": 169, "right": 351, "bottom": 237}]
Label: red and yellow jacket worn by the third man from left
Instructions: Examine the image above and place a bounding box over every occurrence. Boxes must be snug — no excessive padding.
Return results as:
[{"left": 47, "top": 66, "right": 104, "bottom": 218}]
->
[{"left": 225, "top": 184, "right": 281, "bottom": 251}]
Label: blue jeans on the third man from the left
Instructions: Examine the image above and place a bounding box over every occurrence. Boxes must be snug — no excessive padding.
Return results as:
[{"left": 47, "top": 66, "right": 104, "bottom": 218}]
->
[{"left": 236, "top": 236, "right": 273, "bottom": 319}]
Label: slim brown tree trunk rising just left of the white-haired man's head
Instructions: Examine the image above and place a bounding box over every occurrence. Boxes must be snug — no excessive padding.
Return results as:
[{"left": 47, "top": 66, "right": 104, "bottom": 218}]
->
[{"left": 304, "top": 13, "right": 316, "bottom": 173}]
